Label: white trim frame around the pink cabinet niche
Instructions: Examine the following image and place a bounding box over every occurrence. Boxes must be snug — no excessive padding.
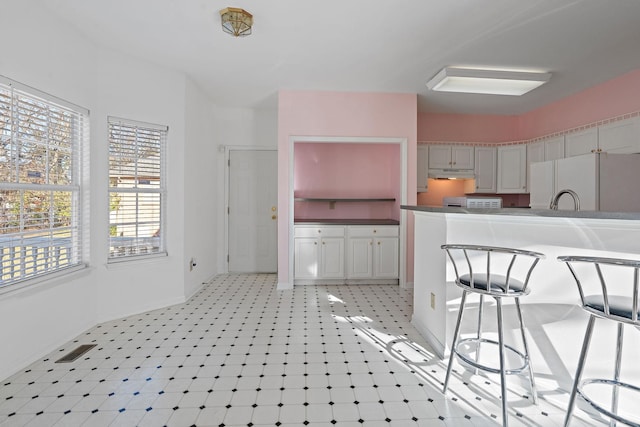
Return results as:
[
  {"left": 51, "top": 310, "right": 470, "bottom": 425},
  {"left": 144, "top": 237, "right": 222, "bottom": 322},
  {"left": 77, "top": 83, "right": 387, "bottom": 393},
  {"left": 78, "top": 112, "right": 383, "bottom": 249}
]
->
[{"left": 288, "top": 135, "right": 409, "bottom": 288}]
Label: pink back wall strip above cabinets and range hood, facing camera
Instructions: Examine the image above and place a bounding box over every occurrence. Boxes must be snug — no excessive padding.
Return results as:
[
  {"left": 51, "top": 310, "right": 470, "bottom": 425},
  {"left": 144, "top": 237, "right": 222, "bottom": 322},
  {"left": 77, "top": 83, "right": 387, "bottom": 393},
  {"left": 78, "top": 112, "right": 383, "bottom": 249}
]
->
[{"left": 418, "top": 113, "right": 519, "bottom": 142}]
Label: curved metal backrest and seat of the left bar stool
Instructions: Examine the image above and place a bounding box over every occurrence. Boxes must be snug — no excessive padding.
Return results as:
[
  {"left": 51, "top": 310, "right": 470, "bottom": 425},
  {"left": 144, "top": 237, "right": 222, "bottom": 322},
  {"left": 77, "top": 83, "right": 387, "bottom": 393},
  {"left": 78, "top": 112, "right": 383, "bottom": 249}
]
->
[{"left": 441, "top": 244, "right": 545, "bottom": 296}]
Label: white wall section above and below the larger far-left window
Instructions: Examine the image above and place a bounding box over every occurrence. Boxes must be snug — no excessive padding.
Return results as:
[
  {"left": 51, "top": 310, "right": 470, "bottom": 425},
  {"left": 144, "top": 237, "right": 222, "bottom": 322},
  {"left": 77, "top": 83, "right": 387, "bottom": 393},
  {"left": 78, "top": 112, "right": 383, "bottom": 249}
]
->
[{"left": 0, "top": 0, "right": 106, "bottom": 378}]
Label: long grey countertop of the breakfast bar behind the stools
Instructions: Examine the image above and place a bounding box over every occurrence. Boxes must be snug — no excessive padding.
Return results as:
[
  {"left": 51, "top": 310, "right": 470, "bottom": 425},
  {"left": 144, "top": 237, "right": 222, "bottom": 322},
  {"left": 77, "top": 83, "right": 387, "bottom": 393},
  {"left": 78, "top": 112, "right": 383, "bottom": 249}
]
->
[{"left": 400, "top": 205, "right": 640, "bottom": 220}]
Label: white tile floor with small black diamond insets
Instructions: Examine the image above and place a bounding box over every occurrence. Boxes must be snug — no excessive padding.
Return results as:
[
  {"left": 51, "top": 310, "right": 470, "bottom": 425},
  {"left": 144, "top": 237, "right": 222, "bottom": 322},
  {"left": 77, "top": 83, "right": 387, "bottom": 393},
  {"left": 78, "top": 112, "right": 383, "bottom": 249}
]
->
[{"left": 0, "top": 274, "right": 594, "bottom": 427}]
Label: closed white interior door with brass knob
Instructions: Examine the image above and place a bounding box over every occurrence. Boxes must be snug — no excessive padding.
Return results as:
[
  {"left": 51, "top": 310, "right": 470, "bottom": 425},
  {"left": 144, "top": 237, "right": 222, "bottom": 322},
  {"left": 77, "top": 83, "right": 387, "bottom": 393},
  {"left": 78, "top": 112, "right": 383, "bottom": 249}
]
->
[{"left": 228, "top": 150, "right": 278, "bottom": 273}]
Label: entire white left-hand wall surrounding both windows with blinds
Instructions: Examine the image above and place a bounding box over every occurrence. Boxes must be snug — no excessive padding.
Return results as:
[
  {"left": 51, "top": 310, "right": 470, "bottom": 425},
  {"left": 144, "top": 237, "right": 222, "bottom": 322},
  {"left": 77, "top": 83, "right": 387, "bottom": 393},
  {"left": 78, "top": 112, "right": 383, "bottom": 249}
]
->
[{"left": 0, "top": 0, "right": 220, "bottom": 378}]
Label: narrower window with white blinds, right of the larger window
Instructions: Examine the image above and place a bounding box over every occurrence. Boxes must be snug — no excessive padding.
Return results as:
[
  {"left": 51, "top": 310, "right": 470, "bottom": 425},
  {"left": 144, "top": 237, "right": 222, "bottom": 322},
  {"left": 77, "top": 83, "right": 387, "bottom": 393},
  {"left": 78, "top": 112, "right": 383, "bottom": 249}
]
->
[{"left": 108, "top": 117, "right": 167, "bottom": 261}]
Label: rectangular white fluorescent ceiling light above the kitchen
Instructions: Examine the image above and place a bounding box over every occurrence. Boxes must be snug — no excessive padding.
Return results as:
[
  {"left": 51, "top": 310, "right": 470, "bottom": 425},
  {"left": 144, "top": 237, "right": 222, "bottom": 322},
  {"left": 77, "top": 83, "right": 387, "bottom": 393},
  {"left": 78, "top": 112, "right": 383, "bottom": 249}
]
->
[{"left": 427, "top": 67, "right": 551, "bottom": 95}]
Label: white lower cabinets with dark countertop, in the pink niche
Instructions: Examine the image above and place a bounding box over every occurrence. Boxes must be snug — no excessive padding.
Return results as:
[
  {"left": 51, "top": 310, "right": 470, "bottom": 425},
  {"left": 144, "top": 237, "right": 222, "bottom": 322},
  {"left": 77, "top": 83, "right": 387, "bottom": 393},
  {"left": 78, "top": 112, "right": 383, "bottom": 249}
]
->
[{"left": 294, "top": 225, "right": 400, "bottom": 284}]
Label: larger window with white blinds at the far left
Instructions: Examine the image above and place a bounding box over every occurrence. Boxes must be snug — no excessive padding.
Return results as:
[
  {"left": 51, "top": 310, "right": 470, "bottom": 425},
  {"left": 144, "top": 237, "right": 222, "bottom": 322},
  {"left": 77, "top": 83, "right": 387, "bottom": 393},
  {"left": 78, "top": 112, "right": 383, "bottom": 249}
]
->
[{"left": 0, "top": 77, "right": 89, "bottom": 288}]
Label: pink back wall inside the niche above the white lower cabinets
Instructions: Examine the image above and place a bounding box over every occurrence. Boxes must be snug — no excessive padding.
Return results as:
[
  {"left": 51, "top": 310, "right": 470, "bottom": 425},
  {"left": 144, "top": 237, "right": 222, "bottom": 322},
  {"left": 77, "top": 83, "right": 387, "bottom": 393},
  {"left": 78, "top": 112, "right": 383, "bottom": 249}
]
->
[{"left": 293, "top": 142, "right": 400, "bottom": 220}]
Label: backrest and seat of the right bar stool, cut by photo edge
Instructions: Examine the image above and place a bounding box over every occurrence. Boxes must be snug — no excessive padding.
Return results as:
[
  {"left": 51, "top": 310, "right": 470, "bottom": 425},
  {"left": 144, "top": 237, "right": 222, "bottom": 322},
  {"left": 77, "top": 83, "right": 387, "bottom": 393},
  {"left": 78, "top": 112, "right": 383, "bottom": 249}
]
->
[{"left": 558, "top": 255, "right": 640, "bottom": 326}]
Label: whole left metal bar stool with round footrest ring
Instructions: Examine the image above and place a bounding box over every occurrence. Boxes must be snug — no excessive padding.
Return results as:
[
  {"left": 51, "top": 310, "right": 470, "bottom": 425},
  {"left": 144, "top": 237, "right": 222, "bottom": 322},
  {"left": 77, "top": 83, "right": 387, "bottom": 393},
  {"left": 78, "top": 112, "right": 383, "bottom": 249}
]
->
[{"left": 441, "top": 244, "right": 545, "bottom": 426}]
